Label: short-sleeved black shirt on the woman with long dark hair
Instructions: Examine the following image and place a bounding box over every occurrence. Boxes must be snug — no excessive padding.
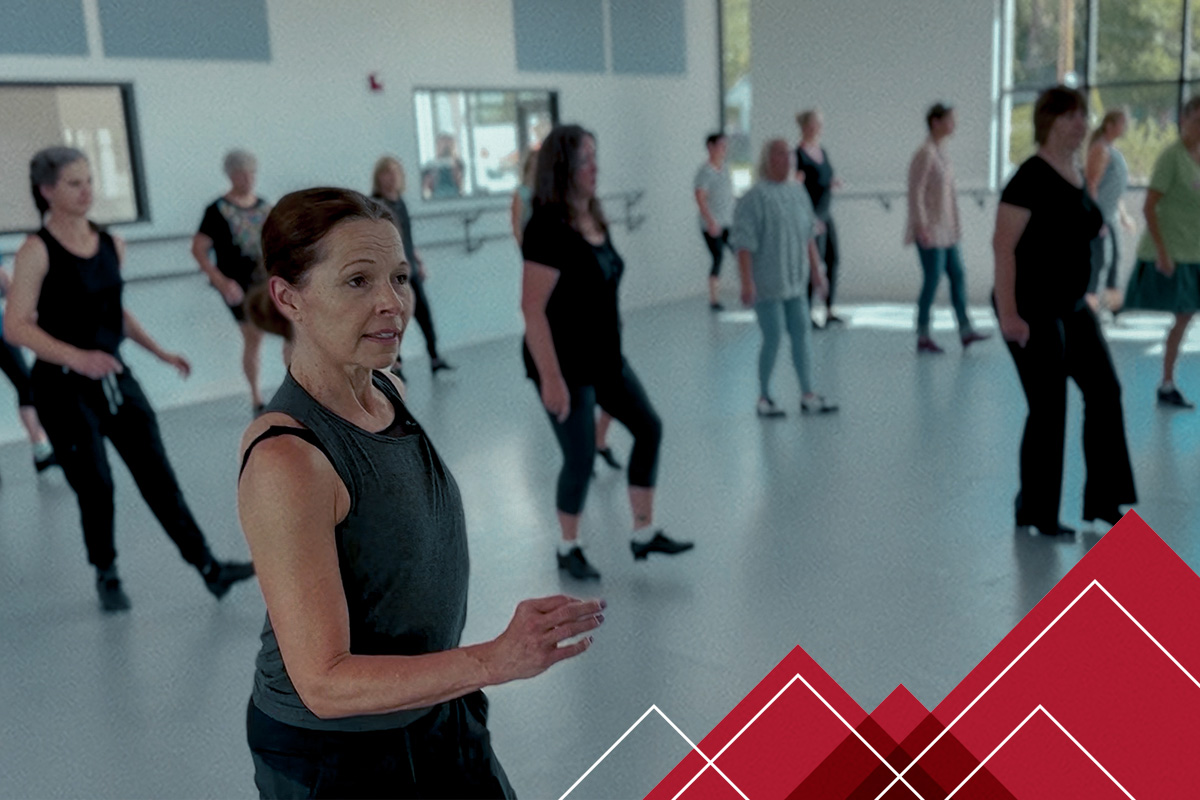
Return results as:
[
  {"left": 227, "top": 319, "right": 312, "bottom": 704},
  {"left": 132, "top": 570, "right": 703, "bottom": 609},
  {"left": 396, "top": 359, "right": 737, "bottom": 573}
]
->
[{"left": 521, "top": 207, "right": 625, "bottom": 386}]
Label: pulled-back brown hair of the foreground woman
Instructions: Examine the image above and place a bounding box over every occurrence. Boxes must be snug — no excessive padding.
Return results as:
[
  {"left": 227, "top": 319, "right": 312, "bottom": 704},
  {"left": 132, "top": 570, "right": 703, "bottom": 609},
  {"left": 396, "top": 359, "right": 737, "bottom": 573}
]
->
[{"left": 246, "top": 187, "right": 396, "bottom": 339}]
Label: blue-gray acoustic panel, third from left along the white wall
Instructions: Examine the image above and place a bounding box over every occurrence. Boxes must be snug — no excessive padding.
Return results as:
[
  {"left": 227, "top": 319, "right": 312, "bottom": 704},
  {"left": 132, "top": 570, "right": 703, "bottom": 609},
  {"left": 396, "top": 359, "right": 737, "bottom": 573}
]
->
[{"left": 512, "top": 0, "right": 605, "bottom": 72}]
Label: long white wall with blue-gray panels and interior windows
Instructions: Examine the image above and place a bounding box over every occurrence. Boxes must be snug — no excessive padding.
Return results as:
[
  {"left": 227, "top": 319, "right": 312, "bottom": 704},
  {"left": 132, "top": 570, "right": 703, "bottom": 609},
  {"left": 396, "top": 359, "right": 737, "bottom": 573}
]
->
[{"left": 0, "top": 0, "right": 719, "bottom": 441}]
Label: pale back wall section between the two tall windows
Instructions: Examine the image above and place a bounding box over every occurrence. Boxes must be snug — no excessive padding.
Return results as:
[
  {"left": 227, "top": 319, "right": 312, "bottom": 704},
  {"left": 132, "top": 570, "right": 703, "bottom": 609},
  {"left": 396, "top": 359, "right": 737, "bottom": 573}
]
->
[{"left": 750, "top": 0, "right": 1000, "bottom": 302}]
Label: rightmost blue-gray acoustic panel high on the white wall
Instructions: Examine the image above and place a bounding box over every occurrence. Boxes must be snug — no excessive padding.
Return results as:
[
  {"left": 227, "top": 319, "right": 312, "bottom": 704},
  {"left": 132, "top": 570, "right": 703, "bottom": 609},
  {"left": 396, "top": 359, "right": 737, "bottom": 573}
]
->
[{"left": 608, "top": 0, "right": 688, "bottom": 74}]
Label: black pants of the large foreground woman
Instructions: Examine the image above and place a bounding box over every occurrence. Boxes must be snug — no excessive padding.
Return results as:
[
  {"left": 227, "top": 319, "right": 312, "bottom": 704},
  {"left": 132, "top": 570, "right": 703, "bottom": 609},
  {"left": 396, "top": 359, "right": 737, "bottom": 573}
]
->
[{"left": 246, "top": 692, "right": 516, "bottom": 800}]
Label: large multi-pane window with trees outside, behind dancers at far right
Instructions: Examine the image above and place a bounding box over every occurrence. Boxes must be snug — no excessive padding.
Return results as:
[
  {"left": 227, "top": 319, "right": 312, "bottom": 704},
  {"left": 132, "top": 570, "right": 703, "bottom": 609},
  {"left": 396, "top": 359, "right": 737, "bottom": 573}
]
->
[{"left": 1000, "top": 0, "right": 1200, "bottom": 185}]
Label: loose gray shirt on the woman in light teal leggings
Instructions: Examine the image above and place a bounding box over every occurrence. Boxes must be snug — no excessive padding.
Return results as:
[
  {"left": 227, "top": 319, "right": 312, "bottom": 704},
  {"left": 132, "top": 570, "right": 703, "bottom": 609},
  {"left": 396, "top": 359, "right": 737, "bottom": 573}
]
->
[{"left": 730, "top": 180, "right": 816, "bottom": 302}]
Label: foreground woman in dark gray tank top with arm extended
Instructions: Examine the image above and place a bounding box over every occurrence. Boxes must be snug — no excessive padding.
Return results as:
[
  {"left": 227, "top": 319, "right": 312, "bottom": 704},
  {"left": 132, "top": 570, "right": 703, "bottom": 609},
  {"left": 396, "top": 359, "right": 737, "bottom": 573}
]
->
[{"left": 238, "top": 188, "right": 604, "bottom": 798}]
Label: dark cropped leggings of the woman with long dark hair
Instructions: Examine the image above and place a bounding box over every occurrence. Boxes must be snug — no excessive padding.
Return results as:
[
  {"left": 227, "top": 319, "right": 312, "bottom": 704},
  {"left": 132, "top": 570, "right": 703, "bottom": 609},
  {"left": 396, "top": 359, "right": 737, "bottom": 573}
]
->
[{"left": 539, "top": 359, "right": 662, "bottom": 515}]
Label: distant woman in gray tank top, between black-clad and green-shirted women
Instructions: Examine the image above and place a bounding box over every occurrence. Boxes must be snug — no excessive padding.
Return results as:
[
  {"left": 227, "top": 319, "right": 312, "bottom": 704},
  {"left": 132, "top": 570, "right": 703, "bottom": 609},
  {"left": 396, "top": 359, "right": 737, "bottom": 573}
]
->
[{"left": 1086, "top": 109, "right": 1133, "bottom": 311}]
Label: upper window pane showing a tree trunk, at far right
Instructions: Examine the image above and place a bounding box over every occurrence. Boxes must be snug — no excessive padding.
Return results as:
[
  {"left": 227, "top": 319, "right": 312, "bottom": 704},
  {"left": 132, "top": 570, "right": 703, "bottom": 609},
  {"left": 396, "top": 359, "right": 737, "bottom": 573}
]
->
[{"left": 1012, "top": 0, "right": 1089, "bottom": 88}]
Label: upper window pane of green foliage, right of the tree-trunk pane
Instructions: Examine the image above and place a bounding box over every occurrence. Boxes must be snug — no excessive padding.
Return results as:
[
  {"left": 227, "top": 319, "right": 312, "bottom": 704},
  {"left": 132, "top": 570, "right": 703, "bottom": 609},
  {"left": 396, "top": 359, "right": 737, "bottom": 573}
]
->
[{"left": 1090, "top": 0, "right": 1183, "bottom": 84}]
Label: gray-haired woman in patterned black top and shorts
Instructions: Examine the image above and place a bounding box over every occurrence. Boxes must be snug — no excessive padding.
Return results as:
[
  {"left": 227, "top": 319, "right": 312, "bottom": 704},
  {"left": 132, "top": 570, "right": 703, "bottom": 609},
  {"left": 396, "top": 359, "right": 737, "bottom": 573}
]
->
[{"left": 192, "top": 150, "right": 271, "bottom": 414}]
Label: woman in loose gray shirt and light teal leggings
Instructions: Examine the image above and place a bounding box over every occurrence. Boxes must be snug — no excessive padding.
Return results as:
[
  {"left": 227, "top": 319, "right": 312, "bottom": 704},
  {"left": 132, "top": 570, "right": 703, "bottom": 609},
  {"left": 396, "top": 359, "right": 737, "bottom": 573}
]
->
[{"left": 730, "top": 139, "right": 838, "bottom": 417}]
